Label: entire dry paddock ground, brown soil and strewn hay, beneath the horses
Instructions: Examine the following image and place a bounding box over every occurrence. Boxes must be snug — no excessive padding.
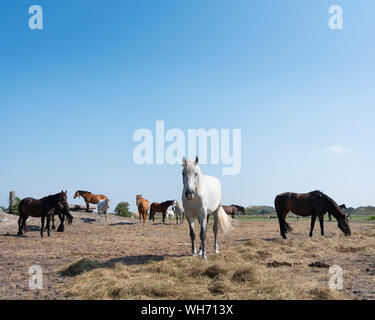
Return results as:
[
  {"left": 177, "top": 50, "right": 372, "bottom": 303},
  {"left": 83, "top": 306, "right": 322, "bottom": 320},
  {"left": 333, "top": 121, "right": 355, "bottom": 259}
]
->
[{"left": 0, "top": 214, "right": 375, "bottom": 299}]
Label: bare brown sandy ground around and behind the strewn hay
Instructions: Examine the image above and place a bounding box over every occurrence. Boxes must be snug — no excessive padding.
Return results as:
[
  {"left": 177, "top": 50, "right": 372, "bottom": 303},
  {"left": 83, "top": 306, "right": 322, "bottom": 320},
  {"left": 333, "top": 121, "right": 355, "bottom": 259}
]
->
[{"left": 0, "top": 213, "right": 375, "bottom": 299}]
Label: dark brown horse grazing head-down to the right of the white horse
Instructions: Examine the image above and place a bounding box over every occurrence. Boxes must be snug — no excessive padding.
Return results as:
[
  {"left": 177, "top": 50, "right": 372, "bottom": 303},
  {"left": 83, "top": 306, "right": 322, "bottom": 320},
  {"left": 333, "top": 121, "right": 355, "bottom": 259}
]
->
[{"left": 275, "top": 191, "right": 351, "bottom": 239}]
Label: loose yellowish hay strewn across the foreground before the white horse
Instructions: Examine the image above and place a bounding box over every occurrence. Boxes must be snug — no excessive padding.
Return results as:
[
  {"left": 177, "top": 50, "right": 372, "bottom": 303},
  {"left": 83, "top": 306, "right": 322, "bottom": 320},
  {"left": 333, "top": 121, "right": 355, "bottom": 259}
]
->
[{"left": 62, "top": 232, "right": 374, "bottom": 300}]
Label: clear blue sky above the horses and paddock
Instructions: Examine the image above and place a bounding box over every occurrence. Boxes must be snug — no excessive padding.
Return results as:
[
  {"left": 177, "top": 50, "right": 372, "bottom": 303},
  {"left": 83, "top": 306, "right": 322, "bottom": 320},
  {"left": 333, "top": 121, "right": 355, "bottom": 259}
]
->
[{"left": 0, "top": 0, "right": 375, "bottom": 210}]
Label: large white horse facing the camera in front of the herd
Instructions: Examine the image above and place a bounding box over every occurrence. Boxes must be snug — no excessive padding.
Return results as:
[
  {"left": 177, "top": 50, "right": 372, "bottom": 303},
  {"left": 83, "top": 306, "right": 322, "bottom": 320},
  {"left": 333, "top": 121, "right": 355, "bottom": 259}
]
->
[{"left": 182, "top": 157, "right": 232, "bottom": 259}]
